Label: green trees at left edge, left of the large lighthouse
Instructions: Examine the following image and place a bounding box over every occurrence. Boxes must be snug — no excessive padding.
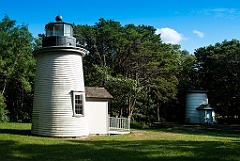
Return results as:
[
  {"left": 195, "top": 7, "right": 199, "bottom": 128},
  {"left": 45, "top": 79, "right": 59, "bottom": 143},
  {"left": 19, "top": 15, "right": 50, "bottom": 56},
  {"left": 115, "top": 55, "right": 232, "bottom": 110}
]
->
[{"left": 0, "top": 16, "right": 35, "bottom": 120}]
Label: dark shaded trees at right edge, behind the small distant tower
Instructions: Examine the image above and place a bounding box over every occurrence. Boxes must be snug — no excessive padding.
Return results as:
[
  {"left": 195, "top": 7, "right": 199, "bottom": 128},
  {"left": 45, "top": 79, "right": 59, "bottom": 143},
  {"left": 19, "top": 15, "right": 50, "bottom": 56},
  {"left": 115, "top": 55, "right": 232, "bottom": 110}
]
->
[{"left": 195, "top": 39, "right": 240, "bottom": 122}]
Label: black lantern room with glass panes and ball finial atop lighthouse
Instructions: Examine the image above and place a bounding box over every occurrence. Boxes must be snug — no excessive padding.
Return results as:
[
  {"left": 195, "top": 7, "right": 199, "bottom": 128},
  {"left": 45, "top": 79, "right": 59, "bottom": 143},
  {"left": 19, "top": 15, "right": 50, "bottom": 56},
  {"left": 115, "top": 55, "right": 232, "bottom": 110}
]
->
[{"left": 42, "top": 16, "right": 76, "bottom": 47}]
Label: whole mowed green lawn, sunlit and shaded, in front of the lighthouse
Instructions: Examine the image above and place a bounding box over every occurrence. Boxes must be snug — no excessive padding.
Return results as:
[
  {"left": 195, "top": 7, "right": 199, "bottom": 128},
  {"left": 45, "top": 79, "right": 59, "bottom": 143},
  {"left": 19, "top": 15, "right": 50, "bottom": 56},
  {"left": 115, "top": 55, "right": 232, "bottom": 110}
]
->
[{"left": 0, "top": 123, "right": 240, "bottom": 161}]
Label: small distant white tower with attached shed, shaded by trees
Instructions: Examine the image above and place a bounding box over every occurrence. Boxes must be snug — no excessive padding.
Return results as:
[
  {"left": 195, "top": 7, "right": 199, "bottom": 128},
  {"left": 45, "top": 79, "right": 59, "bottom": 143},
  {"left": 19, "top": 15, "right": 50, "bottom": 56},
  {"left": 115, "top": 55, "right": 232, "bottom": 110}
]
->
[{"left": 185, "top": 90, "right": 216, "bottom": 124}]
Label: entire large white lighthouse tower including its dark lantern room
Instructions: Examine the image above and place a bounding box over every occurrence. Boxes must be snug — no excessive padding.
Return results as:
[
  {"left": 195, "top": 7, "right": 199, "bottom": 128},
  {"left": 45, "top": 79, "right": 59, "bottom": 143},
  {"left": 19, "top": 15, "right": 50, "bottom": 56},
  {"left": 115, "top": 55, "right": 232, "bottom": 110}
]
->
[{"left": 32, "top": 16, "right": 89, "bottom": 137}]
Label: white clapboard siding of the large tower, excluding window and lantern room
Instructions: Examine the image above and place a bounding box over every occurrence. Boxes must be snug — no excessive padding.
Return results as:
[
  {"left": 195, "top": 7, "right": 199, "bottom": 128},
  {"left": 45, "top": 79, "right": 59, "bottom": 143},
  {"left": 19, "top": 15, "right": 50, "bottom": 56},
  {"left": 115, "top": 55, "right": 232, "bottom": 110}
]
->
[{"left": 32, "top": 47, "right": 89, "bottom": 137}]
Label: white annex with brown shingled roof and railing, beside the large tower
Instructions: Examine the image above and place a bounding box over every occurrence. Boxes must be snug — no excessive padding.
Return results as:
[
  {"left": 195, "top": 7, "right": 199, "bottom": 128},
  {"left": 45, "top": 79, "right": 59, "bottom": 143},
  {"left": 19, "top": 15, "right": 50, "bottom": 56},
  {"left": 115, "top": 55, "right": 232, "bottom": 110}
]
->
[{"left": 85, "top": 87, "right": 130, "bottom": 135}]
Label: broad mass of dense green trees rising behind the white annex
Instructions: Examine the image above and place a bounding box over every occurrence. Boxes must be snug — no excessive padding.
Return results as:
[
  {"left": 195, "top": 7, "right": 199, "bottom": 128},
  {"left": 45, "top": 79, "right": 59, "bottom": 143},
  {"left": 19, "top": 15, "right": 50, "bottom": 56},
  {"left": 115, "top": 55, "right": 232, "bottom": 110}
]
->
[{"left": 75, "top": 18, "right": 184, "bottom": 120}]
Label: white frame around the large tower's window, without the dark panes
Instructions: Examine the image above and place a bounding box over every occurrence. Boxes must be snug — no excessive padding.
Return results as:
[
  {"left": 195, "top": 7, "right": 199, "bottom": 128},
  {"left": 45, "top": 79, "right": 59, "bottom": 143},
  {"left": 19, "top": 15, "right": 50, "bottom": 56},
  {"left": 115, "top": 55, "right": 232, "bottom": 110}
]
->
[{"left": 72, "top": 91, "right": 85, "bottom": 117}]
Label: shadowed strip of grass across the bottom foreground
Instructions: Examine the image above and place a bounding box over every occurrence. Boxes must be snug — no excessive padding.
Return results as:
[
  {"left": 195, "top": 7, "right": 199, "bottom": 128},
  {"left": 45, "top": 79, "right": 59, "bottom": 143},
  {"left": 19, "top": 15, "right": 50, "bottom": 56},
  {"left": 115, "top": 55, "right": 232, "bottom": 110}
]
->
[{"left": 0, "top": 137, "right": 240, "bottom": 161}]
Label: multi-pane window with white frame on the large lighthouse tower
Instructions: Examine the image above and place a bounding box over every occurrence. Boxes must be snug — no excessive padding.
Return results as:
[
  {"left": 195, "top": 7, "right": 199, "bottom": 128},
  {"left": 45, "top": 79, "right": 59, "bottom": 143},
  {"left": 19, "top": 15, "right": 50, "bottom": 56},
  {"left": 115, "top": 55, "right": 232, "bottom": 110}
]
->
[{"left": 73, "top": 91, "right": 84, "bottom": 116}]
